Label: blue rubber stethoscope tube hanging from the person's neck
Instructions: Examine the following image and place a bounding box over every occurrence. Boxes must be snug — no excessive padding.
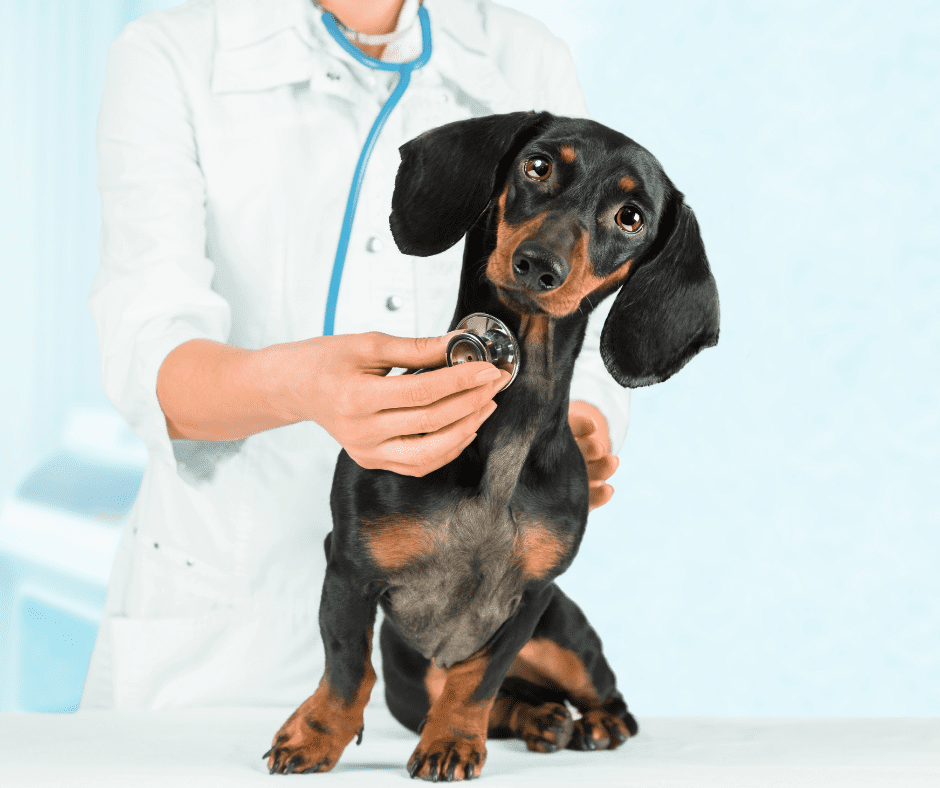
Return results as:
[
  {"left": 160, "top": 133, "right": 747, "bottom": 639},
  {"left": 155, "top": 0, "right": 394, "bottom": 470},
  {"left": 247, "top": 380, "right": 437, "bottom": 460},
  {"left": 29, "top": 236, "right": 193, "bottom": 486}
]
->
[{"left": 322, "top": 6, "right": 431, "bottom": 337}]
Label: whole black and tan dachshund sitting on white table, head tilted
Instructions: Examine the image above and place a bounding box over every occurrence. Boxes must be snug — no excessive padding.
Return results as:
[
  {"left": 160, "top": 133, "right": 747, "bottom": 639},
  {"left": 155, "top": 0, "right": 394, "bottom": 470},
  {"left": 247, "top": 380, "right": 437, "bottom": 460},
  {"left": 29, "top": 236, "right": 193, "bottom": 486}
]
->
[{"left": 265, "top": 112, "right": 718, "bottom": 781}]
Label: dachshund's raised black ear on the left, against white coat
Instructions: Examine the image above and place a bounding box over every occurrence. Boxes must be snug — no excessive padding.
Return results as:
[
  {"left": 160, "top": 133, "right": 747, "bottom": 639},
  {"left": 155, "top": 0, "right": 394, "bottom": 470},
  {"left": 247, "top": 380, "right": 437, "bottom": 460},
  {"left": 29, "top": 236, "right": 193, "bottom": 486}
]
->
[{"left": 389, "top": 112, "right": 552, "bottom": 257}]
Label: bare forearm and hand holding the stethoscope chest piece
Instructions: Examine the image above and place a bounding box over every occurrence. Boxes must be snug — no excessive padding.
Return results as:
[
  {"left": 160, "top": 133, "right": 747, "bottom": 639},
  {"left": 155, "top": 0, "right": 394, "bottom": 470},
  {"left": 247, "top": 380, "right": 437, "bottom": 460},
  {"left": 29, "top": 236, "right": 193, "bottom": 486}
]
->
[{"left": 157, "top": 332, "right": 508, "bottom": 476}]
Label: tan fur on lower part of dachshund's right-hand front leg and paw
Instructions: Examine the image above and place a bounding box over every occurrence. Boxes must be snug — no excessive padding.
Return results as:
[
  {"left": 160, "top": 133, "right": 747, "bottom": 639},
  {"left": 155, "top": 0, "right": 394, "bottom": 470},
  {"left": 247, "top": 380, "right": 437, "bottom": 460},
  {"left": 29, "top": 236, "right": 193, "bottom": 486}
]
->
[{"left": 409, "top": 648, "right": 495, "bottom": 780}]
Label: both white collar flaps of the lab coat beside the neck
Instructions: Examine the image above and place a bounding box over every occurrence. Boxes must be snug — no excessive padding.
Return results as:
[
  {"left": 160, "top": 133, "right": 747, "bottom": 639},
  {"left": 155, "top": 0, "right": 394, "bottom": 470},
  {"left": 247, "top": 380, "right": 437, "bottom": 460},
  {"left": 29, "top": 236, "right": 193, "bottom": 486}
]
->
[{"left": 212, "top": 0, "right": 509, "bottom": 106}]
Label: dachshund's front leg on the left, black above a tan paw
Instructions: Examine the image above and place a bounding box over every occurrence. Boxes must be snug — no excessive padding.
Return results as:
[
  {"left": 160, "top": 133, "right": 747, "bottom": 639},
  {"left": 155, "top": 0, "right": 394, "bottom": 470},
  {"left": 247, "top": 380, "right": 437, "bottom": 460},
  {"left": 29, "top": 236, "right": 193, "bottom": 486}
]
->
[{"left": 265, "top": 562, "right": 376, "bottom": 774}]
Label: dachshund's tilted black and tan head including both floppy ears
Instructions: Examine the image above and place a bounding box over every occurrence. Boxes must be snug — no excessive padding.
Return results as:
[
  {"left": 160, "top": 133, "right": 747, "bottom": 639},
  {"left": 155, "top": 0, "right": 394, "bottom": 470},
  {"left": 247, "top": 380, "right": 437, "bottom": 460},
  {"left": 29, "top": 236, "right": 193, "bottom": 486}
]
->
[{"left": 390, "top": 112, "right": 718, "bottom": 388}]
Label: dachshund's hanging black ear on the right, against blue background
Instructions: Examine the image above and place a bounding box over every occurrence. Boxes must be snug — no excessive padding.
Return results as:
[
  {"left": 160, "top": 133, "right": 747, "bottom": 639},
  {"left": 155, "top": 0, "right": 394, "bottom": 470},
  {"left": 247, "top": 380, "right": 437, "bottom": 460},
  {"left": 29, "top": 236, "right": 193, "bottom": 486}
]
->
[{"left": 601, "top": 192, "right": 719, "bottom": 388}]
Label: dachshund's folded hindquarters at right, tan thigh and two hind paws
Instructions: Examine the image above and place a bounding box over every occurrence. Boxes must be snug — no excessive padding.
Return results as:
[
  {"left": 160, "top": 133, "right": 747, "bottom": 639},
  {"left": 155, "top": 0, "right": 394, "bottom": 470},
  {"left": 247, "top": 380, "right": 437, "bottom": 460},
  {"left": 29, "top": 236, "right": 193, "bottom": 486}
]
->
[{"left": 490, "top": 584, "right": 638, "bottom": 752}]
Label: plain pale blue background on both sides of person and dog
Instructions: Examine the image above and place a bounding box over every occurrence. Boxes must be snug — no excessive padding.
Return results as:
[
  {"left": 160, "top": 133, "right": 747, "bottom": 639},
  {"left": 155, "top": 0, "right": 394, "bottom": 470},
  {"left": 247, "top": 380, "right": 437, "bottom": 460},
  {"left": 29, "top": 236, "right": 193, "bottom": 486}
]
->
[{"left": 0, "top": 0, "right": 940, "bottom": 717}]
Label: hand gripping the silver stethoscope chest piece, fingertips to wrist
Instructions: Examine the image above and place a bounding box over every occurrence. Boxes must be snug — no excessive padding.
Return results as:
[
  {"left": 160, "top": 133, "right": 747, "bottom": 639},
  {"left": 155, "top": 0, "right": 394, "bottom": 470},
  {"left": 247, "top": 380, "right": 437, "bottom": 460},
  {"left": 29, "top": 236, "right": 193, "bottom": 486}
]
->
[{"left": 263, "top": 331, "right": 509, "bottom": 476}]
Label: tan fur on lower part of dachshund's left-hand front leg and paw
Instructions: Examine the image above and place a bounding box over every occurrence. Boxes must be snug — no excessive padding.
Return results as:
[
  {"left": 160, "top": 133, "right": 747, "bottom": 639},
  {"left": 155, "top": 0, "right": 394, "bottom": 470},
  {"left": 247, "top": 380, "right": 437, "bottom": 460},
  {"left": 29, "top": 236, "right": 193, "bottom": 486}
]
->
[{"left": 268, "top": 612, "right": 375, "bottom": 772}]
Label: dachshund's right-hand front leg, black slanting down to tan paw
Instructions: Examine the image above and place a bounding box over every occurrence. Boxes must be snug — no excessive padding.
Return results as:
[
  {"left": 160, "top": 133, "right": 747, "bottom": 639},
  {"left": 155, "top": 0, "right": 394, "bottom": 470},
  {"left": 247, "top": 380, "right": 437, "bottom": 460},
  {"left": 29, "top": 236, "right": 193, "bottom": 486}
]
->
[{"left": 408, "top": 588, "right": 552, "bottom": 782}]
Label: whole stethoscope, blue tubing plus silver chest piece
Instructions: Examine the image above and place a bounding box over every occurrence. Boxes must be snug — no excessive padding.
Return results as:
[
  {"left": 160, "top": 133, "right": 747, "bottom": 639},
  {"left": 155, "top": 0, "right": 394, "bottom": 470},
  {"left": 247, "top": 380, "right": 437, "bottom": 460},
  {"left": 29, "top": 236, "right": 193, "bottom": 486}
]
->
[{"left": 321, "top": 6, "right": 520, "bottom": 390}]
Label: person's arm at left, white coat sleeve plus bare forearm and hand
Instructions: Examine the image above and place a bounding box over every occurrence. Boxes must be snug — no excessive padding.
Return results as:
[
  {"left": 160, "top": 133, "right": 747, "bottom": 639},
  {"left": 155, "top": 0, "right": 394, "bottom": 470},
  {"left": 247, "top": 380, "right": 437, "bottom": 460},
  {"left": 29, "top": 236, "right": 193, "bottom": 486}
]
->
[{"left": 89, "top": 17, "right": 506, "bottom": 475}]
